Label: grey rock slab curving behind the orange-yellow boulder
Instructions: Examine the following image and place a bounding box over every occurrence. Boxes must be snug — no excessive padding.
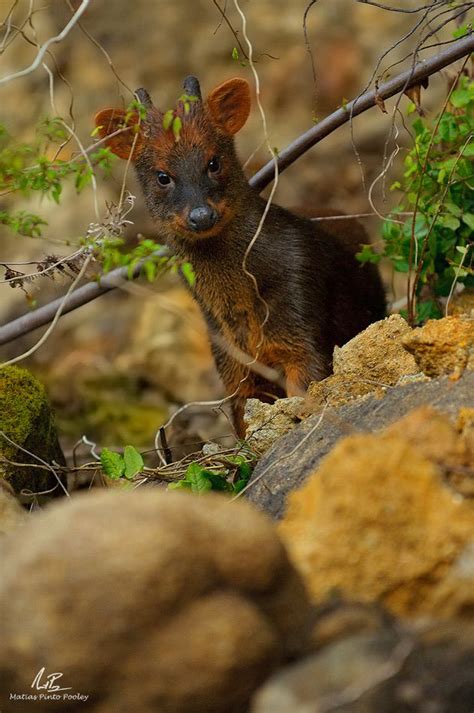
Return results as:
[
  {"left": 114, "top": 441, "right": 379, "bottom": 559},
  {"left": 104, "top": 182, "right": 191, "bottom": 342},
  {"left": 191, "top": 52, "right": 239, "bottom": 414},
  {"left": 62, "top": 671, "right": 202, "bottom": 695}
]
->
[{"left": 247, "top": 370, "right": 474, "bottom": 518}]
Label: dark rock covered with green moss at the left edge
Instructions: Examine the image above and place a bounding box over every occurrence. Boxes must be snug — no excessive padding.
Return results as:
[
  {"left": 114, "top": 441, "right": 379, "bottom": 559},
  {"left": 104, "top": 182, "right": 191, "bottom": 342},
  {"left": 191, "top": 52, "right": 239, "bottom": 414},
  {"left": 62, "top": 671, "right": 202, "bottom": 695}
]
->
[{"left": 0, "top": 366, "right": 65, "bottom": 503}]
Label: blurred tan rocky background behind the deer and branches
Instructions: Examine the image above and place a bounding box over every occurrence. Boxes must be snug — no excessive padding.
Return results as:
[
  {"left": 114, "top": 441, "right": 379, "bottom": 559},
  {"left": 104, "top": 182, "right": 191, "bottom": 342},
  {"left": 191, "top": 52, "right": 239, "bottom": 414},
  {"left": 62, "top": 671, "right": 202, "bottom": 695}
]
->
[{"left": 0, "top": 0, "right": 462, "bottom": 453}]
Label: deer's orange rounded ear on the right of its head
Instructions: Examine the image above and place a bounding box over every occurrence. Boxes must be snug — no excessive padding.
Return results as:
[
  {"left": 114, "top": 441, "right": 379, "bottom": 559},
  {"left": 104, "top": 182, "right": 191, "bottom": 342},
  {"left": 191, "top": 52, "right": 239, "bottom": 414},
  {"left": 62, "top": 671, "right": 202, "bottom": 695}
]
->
[{"left": 207, "top": 77, "right": 250, "bottom": 134}]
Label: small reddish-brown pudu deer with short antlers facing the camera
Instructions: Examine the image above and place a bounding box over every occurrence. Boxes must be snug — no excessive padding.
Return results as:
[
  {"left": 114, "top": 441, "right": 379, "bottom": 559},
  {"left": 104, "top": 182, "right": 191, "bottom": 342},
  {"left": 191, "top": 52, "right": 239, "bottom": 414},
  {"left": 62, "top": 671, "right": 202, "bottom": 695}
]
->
[{"left": 96, "top": 77, "right": 385, "bottom": 437}]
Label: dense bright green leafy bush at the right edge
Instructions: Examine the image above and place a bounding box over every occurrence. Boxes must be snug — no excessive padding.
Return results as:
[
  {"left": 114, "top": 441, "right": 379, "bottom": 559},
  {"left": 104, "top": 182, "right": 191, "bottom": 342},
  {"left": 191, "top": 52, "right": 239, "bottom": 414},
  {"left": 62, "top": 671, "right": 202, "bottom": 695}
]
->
[{"left": 357, "top": 75, "right": 474, "bottom": 322}]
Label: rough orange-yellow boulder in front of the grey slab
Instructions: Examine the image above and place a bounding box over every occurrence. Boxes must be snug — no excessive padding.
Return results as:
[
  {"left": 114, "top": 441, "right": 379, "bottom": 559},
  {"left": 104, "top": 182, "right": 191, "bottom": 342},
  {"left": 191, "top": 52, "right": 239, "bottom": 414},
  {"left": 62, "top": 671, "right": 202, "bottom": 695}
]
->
[{"left": 279, "top": 408, "right": 474, "bottom": 617}]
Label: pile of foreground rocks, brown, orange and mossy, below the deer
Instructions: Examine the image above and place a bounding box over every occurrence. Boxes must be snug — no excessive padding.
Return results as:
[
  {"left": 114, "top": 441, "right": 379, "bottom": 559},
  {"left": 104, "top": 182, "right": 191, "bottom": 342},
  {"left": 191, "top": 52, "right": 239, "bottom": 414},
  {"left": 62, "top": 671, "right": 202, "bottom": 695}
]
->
[{"left": 0, "top": 295, "right": 474, "bottom": 713}]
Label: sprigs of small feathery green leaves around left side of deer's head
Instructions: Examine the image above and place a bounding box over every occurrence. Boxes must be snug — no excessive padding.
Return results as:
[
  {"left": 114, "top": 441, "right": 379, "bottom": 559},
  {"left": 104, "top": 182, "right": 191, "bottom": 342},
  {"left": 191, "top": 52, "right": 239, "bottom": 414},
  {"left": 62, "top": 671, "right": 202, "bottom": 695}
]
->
[{"left": 0, "top": 95, "right": 196, "bottom": 287}]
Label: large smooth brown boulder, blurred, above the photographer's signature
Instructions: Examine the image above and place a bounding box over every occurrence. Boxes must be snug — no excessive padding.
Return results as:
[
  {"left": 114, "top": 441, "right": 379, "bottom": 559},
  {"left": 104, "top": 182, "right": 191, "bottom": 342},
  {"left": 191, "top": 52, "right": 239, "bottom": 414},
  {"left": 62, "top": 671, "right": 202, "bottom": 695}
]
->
[{"left": 0, "top": 490, "right": 309, "bottom": 713}]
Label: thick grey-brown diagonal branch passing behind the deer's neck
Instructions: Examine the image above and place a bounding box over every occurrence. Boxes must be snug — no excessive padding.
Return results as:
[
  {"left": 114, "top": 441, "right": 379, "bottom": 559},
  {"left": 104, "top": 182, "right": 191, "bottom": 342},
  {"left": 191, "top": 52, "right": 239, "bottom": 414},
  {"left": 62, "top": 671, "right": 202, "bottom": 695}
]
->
[{"left": 0, "top": 33, "right": 474, "bottom": 345}]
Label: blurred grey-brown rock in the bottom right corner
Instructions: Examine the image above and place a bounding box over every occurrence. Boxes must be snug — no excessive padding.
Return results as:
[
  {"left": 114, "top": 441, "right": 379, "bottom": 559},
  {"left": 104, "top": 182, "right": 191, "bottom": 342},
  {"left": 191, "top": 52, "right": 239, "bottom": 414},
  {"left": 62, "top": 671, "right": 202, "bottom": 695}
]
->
[{"left": 251, "top": 622, "right": 474, "bottom": 713}]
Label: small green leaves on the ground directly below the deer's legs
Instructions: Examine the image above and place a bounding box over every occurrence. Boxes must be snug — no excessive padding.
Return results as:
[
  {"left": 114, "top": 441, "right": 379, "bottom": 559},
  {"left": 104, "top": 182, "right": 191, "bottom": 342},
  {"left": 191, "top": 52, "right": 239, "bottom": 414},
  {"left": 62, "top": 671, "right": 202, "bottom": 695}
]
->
[{"left": 168, "top": 455, "right": 252, "bottom": 495}]
